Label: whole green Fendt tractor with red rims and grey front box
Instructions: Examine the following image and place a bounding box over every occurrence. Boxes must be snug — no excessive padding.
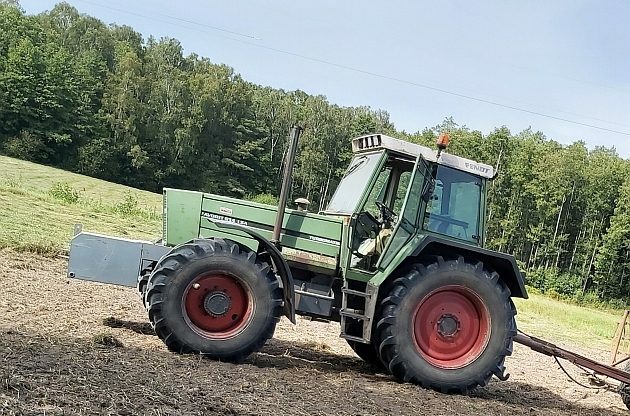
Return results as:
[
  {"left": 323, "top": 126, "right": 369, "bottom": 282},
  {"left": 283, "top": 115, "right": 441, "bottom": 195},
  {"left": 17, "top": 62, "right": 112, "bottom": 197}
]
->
[{"left": 68, "top": 128, "right": 527, "bottom": 393}]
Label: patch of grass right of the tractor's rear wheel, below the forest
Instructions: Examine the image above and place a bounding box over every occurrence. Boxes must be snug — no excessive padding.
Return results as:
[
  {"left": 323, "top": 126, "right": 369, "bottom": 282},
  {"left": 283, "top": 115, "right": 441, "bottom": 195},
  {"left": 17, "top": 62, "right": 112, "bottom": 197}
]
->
[{"left": 514, "top": 294, "right": 623, "bottom": 350}]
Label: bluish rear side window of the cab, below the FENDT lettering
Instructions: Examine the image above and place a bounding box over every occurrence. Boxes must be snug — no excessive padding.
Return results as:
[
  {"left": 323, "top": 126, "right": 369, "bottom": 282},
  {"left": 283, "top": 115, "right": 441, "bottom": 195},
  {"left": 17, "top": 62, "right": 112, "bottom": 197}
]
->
[{"left": 423, "top": 165, "right": 481, "bottom": 243}]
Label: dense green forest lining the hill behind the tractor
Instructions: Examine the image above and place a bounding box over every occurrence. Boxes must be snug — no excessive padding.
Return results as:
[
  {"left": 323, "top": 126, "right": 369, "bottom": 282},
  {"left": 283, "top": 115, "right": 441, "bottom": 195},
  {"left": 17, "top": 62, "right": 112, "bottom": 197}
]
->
[{"left": 0, "top": 0, "right": 630, "bottom": 306}]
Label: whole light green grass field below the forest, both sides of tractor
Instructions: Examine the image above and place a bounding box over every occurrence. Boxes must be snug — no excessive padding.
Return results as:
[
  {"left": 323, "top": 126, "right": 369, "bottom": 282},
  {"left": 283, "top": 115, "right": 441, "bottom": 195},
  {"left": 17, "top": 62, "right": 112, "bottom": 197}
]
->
[{"left": 0, "top": 156, "right": 621, "bottom": 349}]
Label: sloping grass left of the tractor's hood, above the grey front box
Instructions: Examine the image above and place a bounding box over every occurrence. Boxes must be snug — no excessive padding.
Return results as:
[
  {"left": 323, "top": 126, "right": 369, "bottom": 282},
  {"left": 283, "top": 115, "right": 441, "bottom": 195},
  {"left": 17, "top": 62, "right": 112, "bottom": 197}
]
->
[{"left": 0, "top": 156, "right": 162, "bottom": 254}]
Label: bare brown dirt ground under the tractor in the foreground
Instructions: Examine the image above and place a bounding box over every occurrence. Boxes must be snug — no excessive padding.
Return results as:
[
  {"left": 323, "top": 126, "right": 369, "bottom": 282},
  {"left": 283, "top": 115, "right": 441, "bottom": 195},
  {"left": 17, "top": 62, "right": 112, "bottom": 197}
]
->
[{"left": 0, "top": 251, "right": 629, "bottom": 416}]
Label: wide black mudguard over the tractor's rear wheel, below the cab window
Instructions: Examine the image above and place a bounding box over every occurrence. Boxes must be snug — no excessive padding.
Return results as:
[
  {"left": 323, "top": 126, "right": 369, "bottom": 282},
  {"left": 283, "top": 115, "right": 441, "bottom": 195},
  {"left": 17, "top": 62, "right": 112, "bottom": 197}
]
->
[{"left": 413, "top": 235, "right": 528, "bottom": 299}]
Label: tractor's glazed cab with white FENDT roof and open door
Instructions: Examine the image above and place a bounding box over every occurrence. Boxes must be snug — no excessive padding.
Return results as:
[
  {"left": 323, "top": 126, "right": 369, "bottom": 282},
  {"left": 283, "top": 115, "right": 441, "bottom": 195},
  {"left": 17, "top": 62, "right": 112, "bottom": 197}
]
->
[{"left": 325, "top": 135, "right": 493, "bottom": 272}]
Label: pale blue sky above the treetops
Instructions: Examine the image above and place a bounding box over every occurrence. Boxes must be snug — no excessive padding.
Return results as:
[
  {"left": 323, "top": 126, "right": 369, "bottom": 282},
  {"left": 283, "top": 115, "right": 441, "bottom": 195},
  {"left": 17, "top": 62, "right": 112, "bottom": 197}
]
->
[{"left": 20, "top": 0, "right": 630, "bottom": 158}]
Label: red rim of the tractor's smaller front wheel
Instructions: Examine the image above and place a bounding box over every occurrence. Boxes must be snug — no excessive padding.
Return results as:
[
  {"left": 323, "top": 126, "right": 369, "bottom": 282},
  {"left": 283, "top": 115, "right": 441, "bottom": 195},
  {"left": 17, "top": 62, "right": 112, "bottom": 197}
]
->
[{"left": 183, "top": 273, "right": 253, "bottom": 339}]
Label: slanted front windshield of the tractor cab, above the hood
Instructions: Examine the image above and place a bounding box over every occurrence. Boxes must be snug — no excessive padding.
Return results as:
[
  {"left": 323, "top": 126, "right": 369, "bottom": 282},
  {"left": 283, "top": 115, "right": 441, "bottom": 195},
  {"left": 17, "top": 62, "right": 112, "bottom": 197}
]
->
[{"left": 326, "top": 152, "right": 383, "bottom": 214}]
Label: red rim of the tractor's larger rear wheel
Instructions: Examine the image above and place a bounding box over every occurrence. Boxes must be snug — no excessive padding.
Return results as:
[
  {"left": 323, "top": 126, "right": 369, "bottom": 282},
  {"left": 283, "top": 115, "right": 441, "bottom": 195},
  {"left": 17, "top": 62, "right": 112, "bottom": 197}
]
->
[{"left": 412, "top": 285, "right": 491, "bottom": 369}]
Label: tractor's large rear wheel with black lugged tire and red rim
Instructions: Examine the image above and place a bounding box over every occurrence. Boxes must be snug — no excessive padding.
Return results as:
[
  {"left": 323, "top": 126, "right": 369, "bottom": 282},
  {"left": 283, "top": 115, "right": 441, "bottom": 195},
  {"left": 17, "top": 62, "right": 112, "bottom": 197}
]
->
[{"left": 376, "top": 256, "right": 516, "bottom": 394}]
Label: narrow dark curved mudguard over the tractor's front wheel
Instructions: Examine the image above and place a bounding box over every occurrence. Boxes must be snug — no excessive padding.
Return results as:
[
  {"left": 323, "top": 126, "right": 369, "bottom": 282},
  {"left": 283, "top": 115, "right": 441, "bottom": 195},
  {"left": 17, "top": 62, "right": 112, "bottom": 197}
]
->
[{"left": 208, "top": 219, "right": 296, "bottom": 324}]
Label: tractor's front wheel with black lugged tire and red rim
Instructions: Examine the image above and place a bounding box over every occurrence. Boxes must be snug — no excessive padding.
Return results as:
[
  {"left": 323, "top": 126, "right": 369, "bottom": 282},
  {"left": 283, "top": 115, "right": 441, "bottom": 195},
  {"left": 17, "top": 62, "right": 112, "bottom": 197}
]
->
[{"left": 146, "top": 239, "right": 283, "bottom": 362}]
